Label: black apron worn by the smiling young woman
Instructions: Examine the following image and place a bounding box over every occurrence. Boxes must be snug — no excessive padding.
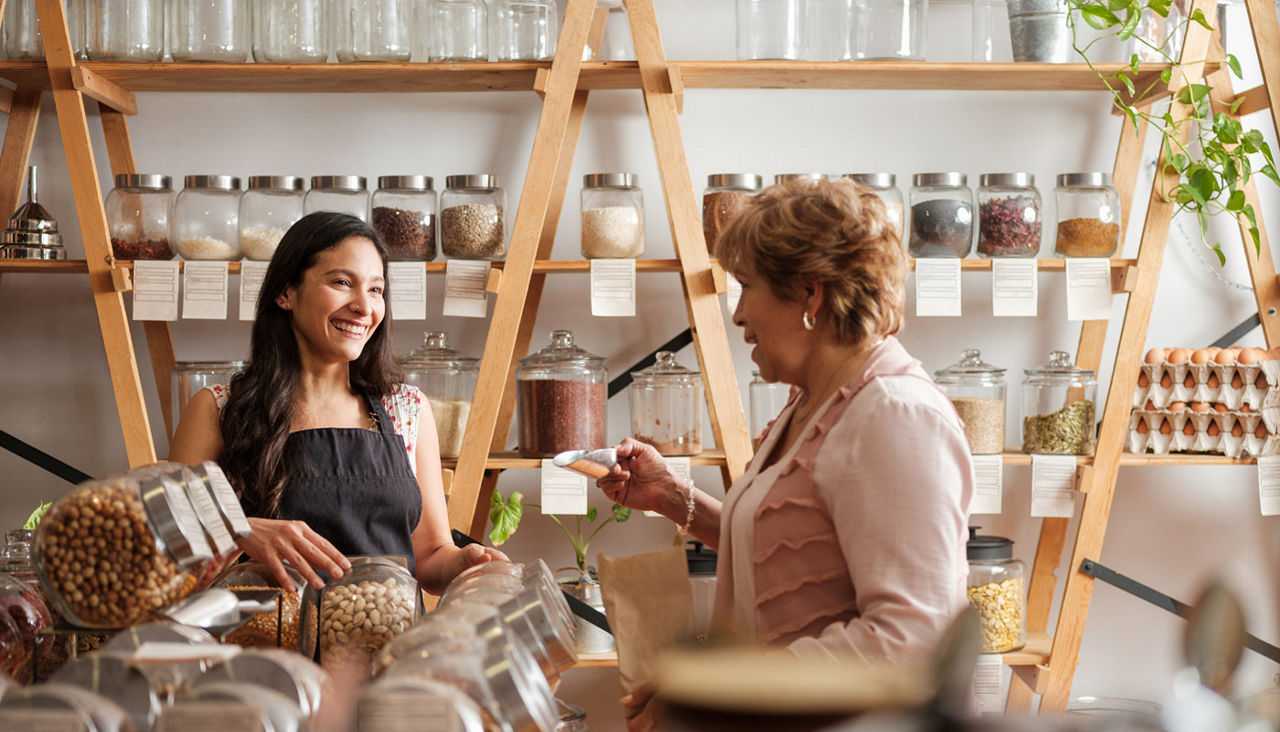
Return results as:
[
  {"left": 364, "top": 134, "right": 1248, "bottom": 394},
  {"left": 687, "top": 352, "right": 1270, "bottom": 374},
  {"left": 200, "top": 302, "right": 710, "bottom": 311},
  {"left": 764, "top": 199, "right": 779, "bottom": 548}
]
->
[{"left": 280, "top": 397, "right": 422, "bottom": 576}]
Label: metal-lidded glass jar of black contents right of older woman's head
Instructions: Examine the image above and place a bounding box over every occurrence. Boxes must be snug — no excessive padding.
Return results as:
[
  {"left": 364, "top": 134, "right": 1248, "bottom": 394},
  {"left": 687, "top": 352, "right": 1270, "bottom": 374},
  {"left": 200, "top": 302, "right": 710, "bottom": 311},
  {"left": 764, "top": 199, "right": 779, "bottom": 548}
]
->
[{"left": 906, "top": 173, "right": 973, "bottom": 257}]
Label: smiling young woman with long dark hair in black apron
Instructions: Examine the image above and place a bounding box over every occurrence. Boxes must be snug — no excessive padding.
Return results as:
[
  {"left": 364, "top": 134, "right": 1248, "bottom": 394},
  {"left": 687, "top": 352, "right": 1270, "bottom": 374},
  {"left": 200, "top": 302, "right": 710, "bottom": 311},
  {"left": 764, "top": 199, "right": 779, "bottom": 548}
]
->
[{"left": 169, "top": 212, "right": 506, "bottom": 593}]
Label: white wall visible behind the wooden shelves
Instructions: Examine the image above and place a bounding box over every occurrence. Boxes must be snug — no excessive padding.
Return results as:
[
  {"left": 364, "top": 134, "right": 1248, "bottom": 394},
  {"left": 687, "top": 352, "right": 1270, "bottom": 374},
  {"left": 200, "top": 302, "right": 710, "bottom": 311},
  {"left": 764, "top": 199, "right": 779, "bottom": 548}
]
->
[{"left": 0, "top": 0, "right": 1280, "bottom": 729}]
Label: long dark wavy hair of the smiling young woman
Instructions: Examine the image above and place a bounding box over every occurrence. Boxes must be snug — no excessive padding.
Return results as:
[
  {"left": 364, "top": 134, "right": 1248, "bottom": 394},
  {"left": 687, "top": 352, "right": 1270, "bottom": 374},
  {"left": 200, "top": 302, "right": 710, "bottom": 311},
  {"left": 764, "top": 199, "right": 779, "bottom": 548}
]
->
[{"left": 219, "top": 211, "right": 401, "bottom": 518}]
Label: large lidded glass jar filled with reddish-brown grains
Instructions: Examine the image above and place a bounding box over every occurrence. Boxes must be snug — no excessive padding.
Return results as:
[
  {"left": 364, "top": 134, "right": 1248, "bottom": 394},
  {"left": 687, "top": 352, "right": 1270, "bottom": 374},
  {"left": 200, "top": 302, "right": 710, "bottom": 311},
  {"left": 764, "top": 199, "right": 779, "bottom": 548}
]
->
[{"left": 516, "top": 330, "right": 609, "bottom": 457}]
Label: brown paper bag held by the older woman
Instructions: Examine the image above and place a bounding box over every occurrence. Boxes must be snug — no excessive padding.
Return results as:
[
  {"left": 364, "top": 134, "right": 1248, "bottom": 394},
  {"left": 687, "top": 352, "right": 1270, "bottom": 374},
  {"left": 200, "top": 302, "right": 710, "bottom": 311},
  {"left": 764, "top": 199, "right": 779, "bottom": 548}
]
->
[{"left": 599, "top": 545, "right": 694, "bottom": 694}]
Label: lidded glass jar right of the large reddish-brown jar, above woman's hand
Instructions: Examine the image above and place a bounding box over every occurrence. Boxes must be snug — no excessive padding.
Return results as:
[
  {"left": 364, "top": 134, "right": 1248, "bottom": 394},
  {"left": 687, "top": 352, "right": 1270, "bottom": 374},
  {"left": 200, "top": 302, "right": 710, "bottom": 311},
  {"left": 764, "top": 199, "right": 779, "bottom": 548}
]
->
[{"left": 631, "top": 351, "right": 703, "bottom": 456}]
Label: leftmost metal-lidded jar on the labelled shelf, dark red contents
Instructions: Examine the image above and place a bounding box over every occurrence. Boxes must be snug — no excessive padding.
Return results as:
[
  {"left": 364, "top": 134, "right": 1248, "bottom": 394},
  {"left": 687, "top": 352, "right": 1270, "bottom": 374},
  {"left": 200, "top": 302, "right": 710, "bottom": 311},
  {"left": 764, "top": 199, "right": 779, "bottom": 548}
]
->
[{"left": 105, "top": 174, "right": 173, "bottom": 260}]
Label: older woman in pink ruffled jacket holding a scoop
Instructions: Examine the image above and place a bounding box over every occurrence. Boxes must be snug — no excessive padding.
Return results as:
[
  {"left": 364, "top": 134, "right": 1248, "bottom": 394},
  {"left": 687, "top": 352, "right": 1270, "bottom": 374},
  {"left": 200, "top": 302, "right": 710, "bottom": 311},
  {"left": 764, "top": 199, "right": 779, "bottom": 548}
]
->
[{"left": 598, "top": 180, "right": 973, "bottom": 726}]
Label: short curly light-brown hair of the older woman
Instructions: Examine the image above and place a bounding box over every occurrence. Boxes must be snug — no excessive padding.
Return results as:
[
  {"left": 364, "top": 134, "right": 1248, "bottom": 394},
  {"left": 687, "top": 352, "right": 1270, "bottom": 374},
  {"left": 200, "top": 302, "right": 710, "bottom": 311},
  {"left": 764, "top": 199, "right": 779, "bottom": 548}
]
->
[{"left": 714, "top": 179, "right": 906, "bottom": 344}]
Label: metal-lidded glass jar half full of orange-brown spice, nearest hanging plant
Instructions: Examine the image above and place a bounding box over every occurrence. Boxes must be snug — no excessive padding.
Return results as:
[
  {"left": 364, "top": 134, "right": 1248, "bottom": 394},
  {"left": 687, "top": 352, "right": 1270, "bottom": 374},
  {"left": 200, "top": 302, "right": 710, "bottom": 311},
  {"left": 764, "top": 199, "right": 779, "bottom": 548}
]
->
[{"left": 1053, "top": 173, "right": 1120, "bottom": 257}]
